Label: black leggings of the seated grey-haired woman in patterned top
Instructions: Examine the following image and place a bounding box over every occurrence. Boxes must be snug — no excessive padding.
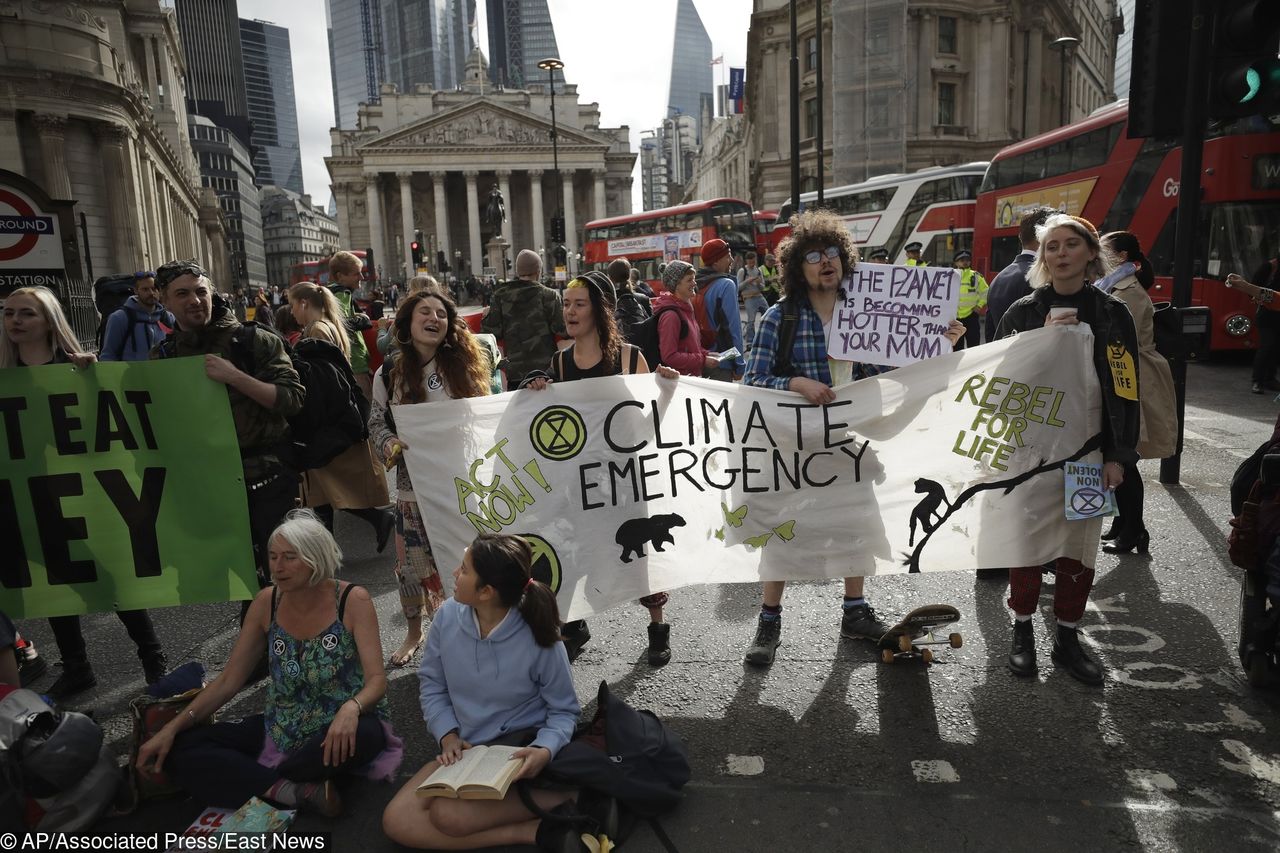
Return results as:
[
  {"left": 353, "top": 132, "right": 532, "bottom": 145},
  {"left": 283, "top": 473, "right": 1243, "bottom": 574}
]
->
[{"left": 165, "top": 713, "right": 387, "bottom": 808}]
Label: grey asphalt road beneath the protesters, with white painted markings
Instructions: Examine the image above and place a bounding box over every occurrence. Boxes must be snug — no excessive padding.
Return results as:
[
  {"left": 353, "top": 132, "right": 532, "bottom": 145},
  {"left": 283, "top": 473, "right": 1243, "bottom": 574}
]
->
[{"left": 12, "top": 350, "right": 1280, "bottom": 853}]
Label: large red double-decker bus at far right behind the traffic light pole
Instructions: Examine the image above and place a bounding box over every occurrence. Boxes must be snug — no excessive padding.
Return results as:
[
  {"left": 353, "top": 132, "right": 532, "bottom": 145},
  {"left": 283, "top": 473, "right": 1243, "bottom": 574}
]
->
[{"left": 973, "top": 101, "right": 1280, "bottom": 352}]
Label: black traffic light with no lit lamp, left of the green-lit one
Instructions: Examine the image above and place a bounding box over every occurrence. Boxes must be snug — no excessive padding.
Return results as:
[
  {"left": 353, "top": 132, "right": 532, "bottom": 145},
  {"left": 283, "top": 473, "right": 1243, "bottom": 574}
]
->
[{"left": 1128, "top": 0, "right": 1192, "bottom": 140}]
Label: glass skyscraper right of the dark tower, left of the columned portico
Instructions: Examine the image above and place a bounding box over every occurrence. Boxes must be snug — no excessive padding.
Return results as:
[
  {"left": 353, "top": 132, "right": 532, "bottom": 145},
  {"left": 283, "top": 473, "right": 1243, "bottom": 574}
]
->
[{"left": 239, "top": 18, "right": 303, "bottom": 196}]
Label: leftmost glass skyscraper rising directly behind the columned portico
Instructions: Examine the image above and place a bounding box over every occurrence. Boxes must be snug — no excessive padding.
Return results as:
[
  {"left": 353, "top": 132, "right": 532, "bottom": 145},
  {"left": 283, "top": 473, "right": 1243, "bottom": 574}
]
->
[{"left": 325, "top": 0, "right": 385, "bottom": 128}]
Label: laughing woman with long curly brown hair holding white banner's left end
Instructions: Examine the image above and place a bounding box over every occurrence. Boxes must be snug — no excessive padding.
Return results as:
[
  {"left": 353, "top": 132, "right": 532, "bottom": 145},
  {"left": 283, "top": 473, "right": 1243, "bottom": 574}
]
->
[{"left": 369, "top": 289, "right": 492, "bottom": 667}]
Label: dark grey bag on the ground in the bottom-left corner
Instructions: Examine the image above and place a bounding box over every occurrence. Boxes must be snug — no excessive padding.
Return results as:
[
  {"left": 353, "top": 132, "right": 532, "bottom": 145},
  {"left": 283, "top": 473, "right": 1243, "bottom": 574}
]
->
[{"left": 0, "top": 688, "right": 120, "bottom": 833}]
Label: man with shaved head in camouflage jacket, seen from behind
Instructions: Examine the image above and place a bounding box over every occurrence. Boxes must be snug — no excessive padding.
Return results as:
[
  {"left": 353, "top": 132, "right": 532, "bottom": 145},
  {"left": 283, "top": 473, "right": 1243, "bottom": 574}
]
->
[{"left": 480, "top": 248, "right": 566, "bottom": 391}]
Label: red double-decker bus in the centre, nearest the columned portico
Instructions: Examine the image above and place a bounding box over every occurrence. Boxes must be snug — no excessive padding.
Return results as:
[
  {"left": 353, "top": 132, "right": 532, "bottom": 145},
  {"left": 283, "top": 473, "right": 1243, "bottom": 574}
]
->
[{"left": 584, "top": 199, "right": 756, "bottom": 289}]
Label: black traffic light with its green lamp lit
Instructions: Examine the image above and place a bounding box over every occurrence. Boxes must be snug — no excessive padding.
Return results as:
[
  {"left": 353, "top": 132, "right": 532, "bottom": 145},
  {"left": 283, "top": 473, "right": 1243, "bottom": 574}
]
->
[{"left": 1208, "top": 0, "right": 1280, "bottom": 119}]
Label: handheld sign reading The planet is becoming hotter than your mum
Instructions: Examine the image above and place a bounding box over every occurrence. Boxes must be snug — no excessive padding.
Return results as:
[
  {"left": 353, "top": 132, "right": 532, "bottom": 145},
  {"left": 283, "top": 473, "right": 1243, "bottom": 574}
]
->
[{"left": 827, "top": 264, "right": 960, "bottom": 368}]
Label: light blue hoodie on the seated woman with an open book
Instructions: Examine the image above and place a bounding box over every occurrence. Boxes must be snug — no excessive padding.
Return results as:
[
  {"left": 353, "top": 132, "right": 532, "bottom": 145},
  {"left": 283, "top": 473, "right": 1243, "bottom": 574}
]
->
[{"left": 417, "top": 598, "right": 582, "bottom": 757}]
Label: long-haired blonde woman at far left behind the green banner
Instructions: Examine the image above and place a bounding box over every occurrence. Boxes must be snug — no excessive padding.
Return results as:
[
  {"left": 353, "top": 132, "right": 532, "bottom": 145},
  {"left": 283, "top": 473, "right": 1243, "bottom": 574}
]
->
[{"left": 0, "top": 287, "right": 166, "bottom": 702}]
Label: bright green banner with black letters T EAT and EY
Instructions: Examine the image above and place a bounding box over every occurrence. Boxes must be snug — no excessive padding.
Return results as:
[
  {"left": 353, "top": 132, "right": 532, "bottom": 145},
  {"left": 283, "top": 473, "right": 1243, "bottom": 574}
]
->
[{"left": 0, "top": 359, "right": 257, "bottom": 619}]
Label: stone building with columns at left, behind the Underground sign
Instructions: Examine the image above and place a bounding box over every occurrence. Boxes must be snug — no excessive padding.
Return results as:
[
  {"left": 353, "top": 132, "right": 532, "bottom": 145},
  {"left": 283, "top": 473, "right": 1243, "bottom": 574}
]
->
[{"left": 0, "top": 0, "right": 228, "bottom": 302}]
